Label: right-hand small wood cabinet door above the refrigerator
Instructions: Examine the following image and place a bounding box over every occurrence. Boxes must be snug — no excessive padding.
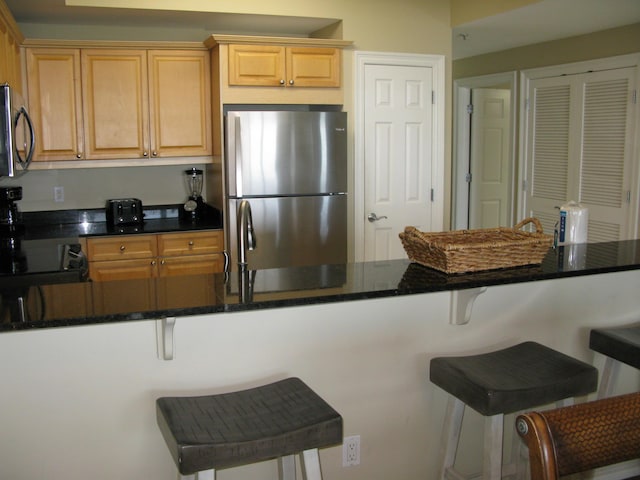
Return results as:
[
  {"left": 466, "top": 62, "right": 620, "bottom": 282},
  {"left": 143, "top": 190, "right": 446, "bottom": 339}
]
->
[{"left": 287, "top": 47, "right": 342, "bottom": 87}]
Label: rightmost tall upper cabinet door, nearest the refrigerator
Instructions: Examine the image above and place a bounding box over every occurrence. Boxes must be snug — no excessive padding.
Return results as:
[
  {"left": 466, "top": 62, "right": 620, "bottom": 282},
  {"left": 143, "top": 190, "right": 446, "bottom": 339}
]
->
[{"left": 148, "top": 50, "right": 212, "bottom": 157}]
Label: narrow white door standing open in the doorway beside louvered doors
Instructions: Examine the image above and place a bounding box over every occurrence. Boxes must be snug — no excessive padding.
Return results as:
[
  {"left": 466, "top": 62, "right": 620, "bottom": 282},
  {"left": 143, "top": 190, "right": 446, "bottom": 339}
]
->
[{"left": 469, "top": 88, "right": 512, "bottom": 228}]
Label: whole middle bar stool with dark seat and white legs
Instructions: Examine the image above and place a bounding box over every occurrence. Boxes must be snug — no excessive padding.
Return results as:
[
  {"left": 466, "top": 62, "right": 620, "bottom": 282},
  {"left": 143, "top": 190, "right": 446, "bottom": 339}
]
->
[{"left": 430, "top": 342, "right": 598, "bottom": 480}]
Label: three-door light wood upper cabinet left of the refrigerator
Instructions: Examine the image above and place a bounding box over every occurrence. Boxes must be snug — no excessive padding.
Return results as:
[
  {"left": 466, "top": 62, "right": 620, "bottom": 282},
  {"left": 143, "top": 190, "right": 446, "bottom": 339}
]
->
[{"left": 25, "top": 42, "right": 212, "bottom": 166}]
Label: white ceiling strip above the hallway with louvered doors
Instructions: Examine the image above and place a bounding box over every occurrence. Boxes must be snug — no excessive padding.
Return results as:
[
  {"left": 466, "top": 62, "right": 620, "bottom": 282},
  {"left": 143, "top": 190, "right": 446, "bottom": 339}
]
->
[{"left": 453, "top": 0, "right": 640, "bottom": 59}]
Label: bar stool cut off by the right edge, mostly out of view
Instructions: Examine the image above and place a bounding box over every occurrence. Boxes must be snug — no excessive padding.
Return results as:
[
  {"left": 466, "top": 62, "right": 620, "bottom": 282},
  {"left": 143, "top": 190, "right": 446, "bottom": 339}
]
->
[{"left": 589, "top": 324, "right": 640, "bottom": 398}]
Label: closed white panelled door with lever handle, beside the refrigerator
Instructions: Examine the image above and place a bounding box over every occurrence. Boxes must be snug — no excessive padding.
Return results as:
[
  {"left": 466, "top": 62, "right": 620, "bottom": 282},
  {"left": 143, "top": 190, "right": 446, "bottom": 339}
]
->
[{"left": 361, "top": 65, "right": 433, "bottom": 261}]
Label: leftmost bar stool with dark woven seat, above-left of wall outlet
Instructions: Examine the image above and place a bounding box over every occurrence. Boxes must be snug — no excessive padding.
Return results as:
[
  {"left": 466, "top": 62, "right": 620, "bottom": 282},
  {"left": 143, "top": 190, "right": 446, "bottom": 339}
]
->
[{"left": 156, "top": 378, "right": 342, "bottom": 480}]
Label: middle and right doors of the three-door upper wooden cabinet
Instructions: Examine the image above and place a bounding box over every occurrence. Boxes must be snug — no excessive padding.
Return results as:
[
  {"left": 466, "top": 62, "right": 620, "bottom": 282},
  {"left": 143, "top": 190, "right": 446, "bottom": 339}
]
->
[{"left": 81, "top": 49, "right": 211, "bottom": 159}]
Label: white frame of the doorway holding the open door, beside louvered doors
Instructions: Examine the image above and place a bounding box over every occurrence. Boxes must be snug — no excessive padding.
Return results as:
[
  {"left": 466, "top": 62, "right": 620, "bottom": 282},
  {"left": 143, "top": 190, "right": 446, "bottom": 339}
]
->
[{"left": 451, "top": 71, "right": 518, "bottom": 230}]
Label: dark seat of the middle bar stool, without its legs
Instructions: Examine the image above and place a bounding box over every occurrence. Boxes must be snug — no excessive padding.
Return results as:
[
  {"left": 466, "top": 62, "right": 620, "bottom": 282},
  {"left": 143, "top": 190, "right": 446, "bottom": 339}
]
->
[{"left": 430, "top": 342, "right": 598, "bottom": 416}]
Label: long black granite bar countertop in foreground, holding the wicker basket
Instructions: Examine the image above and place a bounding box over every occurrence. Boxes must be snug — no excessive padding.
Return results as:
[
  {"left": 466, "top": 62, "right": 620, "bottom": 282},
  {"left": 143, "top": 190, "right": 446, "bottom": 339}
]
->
[{"left": 0, "top": 240, "right": 640, "bottom": 332}]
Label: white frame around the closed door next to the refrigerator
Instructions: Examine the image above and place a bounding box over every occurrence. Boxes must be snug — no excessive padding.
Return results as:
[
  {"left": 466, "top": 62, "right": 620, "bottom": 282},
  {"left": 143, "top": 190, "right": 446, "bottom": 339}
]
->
[{"left": 353, "top": 51, "right": 446, "bottom": 262}]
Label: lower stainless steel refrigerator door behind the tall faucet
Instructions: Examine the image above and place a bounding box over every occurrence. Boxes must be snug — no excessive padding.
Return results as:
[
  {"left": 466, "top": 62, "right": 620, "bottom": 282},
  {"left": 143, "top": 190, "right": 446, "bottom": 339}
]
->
[{"left": 227, "top": 195, "right": 347, "bottom": 270}]
